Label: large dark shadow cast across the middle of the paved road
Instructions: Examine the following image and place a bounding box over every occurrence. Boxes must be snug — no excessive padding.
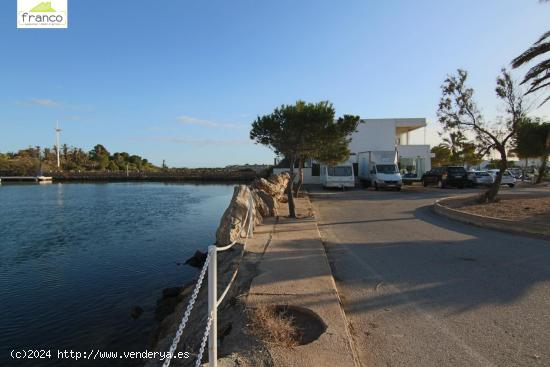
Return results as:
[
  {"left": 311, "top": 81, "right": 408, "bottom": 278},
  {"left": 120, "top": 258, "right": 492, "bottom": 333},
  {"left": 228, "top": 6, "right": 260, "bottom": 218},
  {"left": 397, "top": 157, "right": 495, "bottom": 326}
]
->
[{"left": 325, "top": 205, "right": 550, "bottom": 318}]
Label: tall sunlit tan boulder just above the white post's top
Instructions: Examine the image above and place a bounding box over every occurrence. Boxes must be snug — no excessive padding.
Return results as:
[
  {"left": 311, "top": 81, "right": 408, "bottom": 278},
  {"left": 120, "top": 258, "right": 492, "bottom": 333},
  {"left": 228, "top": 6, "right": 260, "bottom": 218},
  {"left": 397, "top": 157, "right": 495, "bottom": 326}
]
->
[{"left": 216, "top": 185, "right": 256, "bottom": 246}]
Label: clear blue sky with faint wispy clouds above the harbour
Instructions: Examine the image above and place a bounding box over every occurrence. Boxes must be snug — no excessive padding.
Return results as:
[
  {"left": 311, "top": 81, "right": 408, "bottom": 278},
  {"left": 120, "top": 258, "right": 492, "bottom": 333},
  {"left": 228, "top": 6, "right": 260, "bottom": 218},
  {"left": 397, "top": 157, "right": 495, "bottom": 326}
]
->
[{"left": 0, "top": 0, "right": 550, "bottom": 167}]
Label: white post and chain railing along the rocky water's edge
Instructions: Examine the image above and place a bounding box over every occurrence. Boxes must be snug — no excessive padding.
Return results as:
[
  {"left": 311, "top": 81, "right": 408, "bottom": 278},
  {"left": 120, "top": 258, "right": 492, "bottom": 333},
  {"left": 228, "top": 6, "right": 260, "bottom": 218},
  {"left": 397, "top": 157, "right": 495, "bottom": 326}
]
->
[{"left": 163, "top": 193, "right": 255, "bottom": 367}]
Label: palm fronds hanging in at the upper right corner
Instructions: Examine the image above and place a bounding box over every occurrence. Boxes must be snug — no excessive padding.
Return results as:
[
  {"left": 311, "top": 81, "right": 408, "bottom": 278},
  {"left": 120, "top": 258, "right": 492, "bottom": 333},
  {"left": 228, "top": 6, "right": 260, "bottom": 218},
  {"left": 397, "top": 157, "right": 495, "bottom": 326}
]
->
[{"left": 512, "top": 31, "right": 550, "bottom": 107}]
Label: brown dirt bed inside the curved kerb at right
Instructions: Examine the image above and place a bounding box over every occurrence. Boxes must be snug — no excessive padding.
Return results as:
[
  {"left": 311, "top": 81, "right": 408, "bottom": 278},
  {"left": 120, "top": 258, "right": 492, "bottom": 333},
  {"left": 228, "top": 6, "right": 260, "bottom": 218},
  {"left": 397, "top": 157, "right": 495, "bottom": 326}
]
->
[{"left": 457, "top": 196, "right": 550, "bottom": 223}]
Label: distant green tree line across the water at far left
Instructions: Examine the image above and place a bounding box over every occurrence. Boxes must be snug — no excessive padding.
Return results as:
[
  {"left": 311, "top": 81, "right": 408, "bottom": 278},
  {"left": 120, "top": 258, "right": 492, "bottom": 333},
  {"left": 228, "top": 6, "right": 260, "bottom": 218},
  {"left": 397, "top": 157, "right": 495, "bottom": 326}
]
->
[{"left": 0, "top": 144, "right": 162, "bottom": 175}]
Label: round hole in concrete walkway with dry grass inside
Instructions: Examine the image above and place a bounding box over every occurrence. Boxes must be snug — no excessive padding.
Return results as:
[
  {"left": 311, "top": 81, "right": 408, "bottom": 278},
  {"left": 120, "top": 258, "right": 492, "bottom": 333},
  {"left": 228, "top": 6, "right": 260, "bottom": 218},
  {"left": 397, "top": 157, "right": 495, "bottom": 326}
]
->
[{"left": 250, "top": 305, "right": 327, "bottom": 347}]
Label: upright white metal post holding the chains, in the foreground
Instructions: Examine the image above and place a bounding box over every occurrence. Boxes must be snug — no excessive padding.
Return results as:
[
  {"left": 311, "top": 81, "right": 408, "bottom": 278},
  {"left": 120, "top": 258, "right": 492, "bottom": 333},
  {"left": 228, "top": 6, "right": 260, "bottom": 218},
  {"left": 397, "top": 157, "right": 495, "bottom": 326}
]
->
[{"left": 208, "top": 246, "right": 218, "bottom": 367}]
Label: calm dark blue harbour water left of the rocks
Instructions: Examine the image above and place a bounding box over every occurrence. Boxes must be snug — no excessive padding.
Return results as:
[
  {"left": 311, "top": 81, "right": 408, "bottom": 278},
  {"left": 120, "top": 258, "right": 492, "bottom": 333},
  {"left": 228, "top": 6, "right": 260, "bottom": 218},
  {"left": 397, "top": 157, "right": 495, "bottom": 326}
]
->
[{"left": 0, "top": 183, "right": 233, "bottom": 366}]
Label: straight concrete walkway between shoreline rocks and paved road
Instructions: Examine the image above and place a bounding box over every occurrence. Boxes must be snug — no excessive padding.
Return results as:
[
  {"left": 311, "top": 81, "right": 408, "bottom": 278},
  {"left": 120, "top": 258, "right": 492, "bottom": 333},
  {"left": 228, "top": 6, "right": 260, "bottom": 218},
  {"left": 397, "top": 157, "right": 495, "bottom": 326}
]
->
[{"left": 247, "top": 199, "right": 358, "bottom": 367}]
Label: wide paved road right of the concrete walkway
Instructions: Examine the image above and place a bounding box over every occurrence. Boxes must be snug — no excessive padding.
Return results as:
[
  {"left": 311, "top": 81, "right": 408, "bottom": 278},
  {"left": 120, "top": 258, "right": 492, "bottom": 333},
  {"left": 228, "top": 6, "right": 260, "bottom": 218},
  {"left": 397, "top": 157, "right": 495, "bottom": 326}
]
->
[{"left": 311, "top": 187, "right": 550, "bottom": 367}]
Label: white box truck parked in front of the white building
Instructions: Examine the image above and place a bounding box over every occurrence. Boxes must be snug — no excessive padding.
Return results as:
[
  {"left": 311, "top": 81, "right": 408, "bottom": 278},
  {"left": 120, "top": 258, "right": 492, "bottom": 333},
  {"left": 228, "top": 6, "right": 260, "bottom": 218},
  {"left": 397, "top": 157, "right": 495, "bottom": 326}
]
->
[{"left": 357, "top": 150, "right": 403, "bottom": 190}]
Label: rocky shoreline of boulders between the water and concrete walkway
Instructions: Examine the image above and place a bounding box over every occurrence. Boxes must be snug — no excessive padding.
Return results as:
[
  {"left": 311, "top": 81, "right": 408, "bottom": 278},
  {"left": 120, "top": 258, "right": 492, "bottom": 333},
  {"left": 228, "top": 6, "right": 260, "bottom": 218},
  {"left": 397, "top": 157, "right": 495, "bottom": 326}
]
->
[{"left": 146, "top": 173, "right": 290, "bottom": 367}]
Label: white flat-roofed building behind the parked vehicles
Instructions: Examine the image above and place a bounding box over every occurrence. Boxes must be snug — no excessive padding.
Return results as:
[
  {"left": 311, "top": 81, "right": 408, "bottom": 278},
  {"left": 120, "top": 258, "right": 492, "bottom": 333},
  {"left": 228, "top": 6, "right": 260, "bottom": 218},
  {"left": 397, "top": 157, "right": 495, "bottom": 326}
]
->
[{"left": 274, "top": 118, "right": 431, "bottom": 184}]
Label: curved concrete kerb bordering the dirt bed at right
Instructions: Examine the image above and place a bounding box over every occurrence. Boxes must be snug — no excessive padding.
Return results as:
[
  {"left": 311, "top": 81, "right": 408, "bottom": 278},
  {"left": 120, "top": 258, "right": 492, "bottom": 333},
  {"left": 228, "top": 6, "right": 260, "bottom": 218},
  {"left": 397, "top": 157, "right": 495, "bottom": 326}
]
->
[{"left": 432, "top": 196, "right": 550, "bottom": 240}]
